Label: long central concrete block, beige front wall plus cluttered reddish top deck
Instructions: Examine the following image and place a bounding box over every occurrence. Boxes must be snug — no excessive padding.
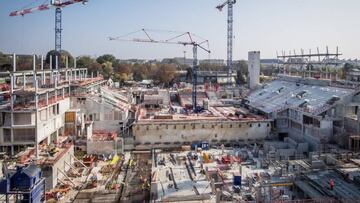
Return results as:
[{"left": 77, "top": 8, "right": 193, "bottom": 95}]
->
[{"left": 132, "top": 95, "right": 271, "bottom": 149}]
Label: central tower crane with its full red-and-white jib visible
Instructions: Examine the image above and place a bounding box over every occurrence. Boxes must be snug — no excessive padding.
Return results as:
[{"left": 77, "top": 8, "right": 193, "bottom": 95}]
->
[{"left": 109, "top": 29, "right": 210, "bottom": 113}]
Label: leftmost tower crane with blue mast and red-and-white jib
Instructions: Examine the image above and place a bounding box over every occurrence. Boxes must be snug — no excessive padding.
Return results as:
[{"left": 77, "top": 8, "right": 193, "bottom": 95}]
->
[{"left": 9, "top": 0, "right": 89, "bottom": 53}]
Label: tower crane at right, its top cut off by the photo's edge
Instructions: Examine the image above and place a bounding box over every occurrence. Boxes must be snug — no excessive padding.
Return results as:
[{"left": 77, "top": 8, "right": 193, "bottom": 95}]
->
[{"left": 216, "top": 0, "right": 236, "bottom": 86}]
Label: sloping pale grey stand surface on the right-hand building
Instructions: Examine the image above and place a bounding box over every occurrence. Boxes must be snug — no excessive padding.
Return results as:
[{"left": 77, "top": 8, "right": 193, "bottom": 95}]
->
[{"left": 246, "top": 80, "right": 355, "bottom": 115}]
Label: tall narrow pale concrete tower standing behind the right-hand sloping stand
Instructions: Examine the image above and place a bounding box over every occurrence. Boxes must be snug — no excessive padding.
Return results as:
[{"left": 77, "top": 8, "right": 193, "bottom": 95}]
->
[{"left": 248, "top": 51, "right": 260, "bottom": 89}]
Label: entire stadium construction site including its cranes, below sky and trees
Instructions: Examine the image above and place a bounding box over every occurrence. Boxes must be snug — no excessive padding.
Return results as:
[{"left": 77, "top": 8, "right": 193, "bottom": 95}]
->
[{"left": 0, "top": 0, "right": 360, "bottom": 203}]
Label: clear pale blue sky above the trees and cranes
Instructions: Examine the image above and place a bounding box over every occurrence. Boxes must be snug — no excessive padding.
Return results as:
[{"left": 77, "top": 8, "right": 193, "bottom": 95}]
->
[{"left": 0, "top": 0, "right": 360, "bottom": 59}]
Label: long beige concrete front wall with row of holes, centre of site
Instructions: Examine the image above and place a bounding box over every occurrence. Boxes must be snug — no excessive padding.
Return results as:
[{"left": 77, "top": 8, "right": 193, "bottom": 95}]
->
[{"left": 133, "top": 121, "right": 271, "bottom": 149}]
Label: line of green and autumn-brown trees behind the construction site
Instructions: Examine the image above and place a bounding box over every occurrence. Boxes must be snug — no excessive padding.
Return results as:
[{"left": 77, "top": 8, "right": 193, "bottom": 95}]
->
[{"left": 0, "top": 50, "right": 255, "bottom": 86}]
